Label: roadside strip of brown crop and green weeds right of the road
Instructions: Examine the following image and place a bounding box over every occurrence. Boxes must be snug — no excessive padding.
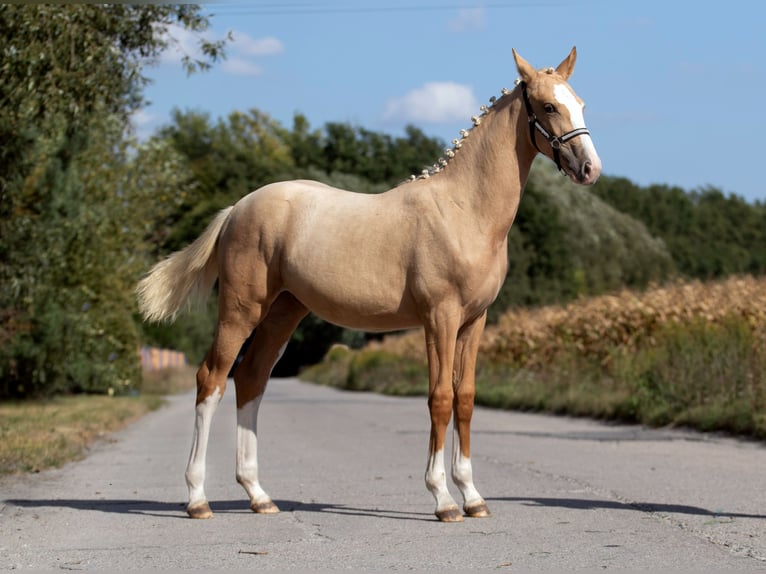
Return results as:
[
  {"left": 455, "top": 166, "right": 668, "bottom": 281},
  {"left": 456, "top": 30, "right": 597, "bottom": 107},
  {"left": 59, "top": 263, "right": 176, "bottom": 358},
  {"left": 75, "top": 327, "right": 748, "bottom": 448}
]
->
[{"left": 302, "top": 277, "right": 766, "bottom": 438}]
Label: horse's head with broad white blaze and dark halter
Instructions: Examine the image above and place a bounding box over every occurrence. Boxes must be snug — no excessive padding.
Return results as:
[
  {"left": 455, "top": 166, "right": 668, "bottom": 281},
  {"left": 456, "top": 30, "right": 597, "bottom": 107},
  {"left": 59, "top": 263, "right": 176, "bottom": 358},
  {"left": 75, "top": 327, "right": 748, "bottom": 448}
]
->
[{"left": 513, "top": 48, "right": 601, "bottom": 185}]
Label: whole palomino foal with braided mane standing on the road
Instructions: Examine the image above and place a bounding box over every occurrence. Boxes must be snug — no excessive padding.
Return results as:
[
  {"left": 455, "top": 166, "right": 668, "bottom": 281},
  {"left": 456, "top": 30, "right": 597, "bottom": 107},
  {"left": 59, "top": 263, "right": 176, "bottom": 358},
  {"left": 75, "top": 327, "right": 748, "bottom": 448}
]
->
[{"left": 137, "top": 48, "right": 601, "bottom": 522}]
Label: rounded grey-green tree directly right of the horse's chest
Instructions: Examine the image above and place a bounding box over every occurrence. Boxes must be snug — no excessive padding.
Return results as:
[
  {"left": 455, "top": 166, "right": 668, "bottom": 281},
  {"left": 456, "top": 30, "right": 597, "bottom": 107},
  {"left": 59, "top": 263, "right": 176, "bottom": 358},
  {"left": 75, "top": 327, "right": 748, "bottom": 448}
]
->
[{"left": 489, "top": 160, "right": 674, "bottom": 321}]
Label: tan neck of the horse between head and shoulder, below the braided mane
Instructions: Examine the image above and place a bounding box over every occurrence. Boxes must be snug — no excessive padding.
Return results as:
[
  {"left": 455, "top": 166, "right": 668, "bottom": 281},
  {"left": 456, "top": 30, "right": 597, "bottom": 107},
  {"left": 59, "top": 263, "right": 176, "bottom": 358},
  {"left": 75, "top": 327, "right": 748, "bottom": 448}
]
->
[{"left": 433, "top": 89, "right": 536, "bottom": 245}]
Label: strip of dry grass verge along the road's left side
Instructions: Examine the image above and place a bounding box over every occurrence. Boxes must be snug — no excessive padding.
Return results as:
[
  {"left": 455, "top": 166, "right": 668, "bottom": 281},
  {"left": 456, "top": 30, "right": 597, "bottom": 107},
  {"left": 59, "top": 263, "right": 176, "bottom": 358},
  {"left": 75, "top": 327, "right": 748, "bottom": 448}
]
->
[{"left": 0, "top": 367, "right": 194, "bottom": 475}]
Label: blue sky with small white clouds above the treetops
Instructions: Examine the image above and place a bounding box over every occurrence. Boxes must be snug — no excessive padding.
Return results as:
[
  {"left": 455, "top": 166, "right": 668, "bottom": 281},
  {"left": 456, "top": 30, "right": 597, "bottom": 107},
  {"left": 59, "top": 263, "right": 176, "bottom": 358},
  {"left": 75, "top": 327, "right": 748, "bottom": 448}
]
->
[{"left": 135, "top": 0, "right": 766, "bottom": 201}]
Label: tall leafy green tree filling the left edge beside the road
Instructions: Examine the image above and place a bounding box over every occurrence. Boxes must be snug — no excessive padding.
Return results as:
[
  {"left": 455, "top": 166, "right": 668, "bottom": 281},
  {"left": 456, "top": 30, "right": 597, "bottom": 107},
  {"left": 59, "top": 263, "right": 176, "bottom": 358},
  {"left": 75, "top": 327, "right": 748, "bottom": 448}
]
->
[{"left": 0, "top": 4, "right": 222, "bottom": 396}]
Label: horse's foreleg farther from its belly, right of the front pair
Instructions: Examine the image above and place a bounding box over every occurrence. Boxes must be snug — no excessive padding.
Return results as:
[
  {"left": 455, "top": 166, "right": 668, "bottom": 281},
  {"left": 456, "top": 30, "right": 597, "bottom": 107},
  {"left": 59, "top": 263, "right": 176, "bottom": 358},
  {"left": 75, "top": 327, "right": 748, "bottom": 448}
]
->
[{"left": 452, "top": 313, "right": 489, "bottom": 518}]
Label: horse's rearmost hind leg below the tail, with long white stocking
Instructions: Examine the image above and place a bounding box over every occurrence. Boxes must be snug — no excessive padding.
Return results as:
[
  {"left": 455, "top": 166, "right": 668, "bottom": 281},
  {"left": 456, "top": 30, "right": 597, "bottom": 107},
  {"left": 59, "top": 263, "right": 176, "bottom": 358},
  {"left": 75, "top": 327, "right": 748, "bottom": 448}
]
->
[{"left": 186, "top": 310, "right": 260, "bottom": 518}]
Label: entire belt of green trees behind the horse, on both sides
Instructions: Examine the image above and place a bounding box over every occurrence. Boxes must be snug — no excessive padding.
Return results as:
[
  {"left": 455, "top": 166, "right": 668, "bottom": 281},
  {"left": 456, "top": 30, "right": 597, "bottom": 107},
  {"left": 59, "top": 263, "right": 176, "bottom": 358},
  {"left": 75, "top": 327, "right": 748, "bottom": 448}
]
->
[{"left": 0, "top": 4, "right": 766, "bottom": 397}]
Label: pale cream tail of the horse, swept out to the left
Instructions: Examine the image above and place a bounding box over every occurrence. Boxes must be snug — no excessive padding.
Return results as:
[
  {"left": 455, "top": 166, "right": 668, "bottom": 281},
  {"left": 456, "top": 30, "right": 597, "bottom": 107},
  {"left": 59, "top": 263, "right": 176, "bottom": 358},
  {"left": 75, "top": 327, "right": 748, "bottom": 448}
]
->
[{"left": 136, "top": 206, "right": 233, "bottom": 321}]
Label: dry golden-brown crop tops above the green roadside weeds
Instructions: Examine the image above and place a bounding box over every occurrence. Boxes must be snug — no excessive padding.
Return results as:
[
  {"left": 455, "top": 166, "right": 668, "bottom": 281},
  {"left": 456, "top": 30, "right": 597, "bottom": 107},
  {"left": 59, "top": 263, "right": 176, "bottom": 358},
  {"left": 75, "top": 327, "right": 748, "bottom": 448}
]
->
[{"left": 367, "top": 277, "right": 766, "bottom": 367}]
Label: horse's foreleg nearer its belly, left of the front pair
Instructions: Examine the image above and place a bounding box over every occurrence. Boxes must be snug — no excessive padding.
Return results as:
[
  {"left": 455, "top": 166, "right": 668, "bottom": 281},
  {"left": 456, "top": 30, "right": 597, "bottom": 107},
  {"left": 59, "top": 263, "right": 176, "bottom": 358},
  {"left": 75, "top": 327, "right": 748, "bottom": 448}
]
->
[{"left": 425, "top": 313, "right": 463, "bottom": 522}]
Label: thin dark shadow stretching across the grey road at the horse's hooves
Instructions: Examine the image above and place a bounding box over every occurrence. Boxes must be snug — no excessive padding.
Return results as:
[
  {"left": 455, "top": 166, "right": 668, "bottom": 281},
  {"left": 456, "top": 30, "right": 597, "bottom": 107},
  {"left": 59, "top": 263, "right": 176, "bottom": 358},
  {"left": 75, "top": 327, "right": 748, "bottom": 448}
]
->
[{"left": 4, "top": 496, "right": 766, "bottom": 522}]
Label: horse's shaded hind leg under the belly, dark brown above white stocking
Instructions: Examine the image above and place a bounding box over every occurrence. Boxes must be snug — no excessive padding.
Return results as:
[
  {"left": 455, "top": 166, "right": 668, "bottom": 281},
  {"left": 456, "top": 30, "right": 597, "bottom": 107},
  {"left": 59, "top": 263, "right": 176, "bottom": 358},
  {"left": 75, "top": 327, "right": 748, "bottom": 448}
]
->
[{"left": 234, "top": 293, "right": 308, "bottom": 514}]
